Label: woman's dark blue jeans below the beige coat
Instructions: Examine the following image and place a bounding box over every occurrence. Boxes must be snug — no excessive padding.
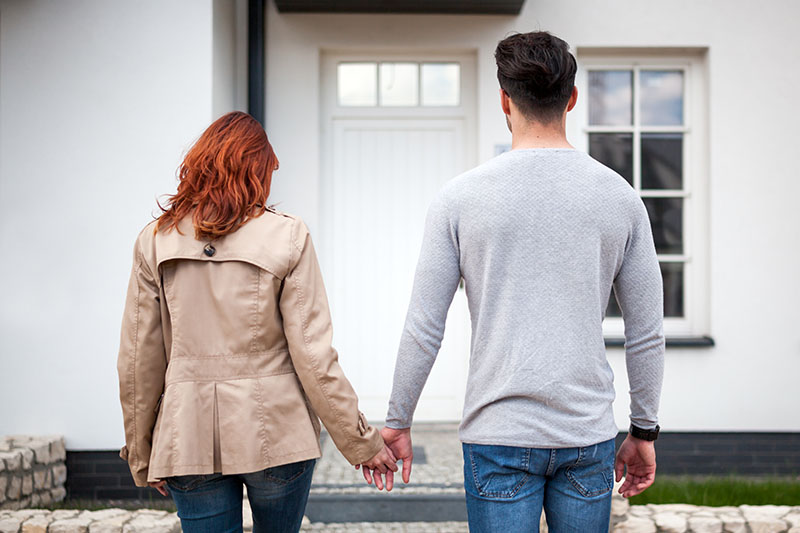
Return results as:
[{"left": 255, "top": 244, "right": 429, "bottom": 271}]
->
[{"left": 167, "top": 459, "right": 316, "bottom": 533}]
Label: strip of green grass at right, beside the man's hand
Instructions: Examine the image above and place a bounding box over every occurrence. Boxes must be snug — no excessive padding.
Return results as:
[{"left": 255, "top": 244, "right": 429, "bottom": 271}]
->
[{"left": 630, "top": 476, "right": 800, "bottom": 507}]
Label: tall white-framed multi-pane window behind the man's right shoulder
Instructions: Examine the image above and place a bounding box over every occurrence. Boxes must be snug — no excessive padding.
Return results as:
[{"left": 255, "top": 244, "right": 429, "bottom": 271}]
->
[{"left": 576, "top": 52, "right": 708, "bottom": 336}]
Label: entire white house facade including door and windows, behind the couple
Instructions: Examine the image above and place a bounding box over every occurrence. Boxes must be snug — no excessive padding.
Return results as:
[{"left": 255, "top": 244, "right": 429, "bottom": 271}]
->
[{"left": 0, "top": 0, "right": 800, "bottom": 494}]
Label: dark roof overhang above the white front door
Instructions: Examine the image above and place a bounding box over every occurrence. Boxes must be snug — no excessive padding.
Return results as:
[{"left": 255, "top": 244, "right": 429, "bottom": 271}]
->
[{"left": 275, "top": 0, "right": 525, "bottom": 15}]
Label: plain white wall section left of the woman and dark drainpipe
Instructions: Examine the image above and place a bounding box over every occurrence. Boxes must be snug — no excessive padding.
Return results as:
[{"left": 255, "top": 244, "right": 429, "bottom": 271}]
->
[{"left": 0, "top": 0, "right": 223, "bottom": 449}]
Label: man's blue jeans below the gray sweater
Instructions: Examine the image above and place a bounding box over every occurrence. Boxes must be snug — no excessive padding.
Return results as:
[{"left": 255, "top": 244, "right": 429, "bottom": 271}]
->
[{"left": 463, "top": 439, "right": 614, "bottom": 533}]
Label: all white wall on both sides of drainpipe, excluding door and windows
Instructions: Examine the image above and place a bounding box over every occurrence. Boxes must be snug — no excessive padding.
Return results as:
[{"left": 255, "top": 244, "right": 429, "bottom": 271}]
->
[{"left": 0, "top": 0, "right": 800, "bottom": 449}]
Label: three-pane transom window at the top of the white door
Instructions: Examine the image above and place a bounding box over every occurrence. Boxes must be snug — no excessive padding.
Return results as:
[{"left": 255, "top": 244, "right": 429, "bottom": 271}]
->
[{"left": 337, "top": 61, "right": 461, "bottom": 107}]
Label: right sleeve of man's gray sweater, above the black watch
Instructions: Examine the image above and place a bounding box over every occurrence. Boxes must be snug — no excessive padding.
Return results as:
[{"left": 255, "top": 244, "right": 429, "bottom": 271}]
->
[{"left": 614, "top": 200, "right": 664, "bottom": 429}]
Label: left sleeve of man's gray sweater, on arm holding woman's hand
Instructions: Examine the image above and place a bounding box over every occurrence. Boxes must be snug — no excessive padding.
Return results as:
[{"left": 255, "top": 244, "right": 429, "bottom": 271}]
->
[{"left": 386, "top": 194, "right": 461, "bottom": 429}]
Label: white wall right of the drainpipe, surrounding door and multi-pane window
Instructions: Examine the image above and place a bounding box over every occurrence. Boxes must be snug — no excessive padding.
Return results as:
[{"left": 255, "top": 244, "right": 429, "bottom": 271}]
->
[{"left": 267, "top": 0, "right": 800, "bottom": 431}]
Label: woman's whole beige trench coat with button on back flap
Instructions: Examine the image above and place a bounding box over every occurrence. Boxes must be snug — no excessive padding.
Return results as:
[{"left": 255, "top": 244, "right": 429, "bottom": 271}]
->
[{"left": 117, "top": 210, "right": 383, "bottom": 486}]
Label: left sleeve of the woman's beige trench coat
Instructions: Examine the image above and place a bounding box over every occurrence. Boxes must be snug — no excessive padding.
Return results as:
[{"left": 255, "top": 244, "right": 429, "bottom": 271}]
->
[{"left": 117, "top": 233, "right": 167, "bottom": 487}]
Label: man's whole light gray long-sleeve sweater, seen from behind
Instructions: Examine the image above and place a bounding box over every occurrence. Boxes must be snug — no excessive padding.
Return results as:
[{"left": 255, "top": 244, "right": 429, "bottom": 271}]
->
[{"left": 386, "top": 149, "right": 664, "bottom": 448}]
